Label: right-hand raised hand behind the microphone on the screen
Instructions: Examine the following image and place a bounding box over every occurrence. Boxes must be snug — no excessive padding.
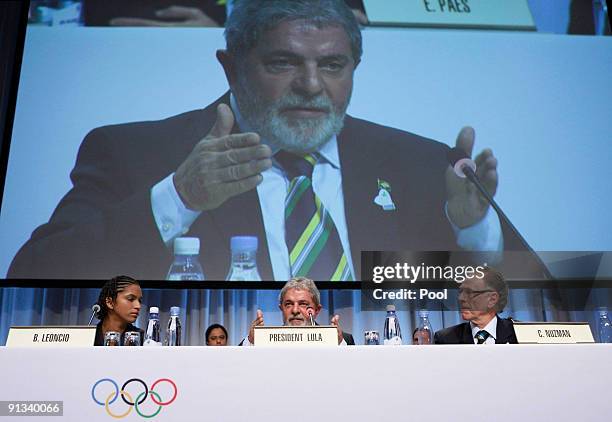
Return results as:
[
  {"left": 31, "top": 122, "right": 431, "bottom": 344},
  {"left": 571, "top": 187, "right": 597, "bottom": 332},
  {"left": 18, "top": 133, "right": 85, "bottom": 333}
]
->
[{"left": 446, "top": 126, "right": 498, "bottom": 228}]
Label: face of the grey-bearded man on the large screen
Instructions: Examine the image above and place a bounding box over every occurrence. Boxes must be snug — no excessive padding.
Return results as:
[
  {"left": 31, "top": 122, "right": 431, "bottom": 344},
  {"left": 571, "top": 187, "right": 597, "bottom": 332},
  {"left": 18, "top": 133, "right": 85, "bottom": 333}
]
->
[{"left": 233, "top": 23, "right": 358, "bottom": 154}]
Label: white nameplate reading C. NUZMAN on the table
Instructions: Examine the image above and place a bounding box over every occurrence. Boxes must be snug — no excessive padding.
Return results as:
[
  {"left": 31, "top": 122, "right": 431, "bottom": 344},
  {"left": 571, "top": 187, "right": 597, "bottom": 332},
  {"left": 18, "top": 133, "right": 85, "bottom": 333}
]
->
[{"left": 514, "top": 321, "right": 595, "bottom": 344}]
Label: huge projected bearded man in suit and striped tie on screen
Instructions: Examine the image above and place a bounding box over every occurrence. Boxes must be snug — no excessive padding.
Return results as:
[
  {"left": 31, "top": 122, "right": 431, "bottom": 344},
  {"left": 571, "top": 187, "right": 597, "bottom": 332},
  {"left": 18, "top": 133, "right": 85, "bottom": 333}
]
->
[{"left": 9, "top": 0, "right": 504, "bottom": 281}]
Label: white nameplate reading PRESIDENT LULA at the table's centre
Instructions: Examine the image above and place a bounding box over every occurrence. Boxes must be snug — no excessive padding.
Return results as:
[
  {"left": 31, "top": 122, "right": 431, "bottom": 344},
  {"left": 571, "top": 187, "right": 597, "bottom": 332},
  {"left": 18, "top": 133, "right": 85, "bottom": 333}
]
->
[{"left": 254, "top": 325, "right": 338, "bottom": 347}]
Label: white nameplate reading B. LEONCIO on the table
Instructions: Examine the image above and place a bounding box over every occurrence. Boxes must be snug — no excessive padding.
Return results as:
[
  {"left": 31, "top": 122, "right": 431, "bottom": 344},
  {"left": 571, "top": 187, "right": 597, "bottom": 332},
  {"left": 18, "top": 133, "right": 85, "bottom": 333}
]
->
[{"left": 6, "top": 325, "right": 96, "bottom": 347}]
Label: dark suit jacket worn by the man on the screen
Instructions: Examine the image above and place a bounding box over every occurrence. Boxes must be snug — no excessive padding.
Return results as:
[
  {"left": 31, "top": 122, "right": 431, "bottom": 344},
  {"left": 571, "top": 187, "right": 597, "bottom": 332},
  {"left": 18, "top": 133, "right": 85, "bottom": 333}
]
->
[{"left": 8, "top": 94, "right": 524, "bottom": 280}]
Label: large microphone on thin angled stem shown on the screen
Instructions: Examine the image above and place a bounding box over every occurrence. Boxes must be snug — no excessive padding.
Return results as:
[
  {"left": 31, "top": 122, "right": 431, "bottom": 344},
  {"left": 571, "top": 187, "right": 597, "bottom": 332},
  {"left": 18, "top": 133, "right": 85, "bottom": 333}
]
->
[{"left": 447, "top": 147, "right": 554, "bottom": 280}]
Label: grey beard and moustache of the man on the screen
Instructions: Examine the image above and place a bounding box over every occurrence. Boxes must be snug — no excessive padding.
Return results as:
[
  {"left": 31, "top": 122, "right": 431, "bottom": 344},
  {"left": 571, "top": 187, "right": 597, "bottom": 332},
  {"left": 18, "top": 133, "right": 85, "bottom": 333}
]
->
[{"left": 234, "top": 77, "right": 350, "bottom": 154}]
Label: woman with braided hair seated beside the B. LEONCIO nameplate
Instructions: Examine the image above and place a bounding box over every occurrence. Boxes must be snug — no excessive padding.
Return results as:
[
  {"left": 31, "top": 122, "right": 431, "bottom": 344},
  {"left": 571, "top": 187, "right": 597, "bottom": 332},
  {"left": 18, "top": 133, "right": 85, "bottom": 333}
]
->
[{"left": 94, "top": 275, "right": 143, "bottom": 346}]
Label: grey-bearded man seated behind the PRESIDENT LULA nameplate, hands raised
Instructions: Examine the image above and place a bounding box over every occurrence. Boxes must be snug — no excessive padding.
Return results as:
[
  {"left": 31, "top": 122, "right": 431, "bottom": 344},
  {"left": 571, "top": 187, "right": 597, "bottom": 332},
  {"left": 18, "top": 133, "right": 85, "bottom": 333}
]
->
[{"left": 239, "top": 277, "right": 355, "bottom": 346}]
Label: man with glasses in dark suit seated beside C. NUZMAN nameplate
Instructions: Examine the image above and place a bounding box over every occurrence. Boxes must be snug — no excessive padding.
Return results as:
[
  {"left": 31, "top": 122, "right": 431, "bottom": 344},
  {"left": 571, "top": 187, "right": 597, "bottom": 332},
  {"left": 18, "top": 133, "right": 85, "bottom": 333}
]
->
[{"left": 434, "top": 267, "right": 517, "bottom": 344}]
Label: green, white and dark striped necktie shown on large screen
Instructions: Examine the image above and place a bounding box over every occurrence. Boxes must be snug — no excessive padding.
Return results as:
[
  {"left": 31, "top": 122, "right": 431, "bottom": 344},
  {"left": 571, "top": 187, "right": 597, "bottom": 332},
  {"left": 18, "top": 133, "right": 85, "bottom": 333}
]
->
[{"left": 276, "top": 151, "right": 353, "bottom": 281}]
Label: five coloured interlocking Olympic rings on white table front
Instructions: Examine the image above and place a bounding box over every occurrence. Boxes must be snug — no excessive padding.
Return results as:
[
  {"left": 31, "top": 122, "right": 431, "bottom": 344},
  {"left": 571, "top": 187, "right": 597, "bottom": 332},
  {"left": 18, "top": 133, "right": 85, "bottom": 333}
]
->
[{"left": 91, "top": 378, "right": 178, "bottom": 419}]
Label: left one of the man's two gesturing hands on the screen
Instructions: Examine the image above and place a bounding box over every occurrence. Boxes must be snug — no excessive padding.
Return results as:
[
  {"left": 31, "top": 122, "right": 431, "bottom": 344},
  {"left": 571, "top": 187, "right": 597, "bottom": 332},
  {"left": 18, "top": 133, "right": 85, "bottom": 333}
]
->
[{"left": 173, "top": 104, "right": 272, "bottom": 211}]
